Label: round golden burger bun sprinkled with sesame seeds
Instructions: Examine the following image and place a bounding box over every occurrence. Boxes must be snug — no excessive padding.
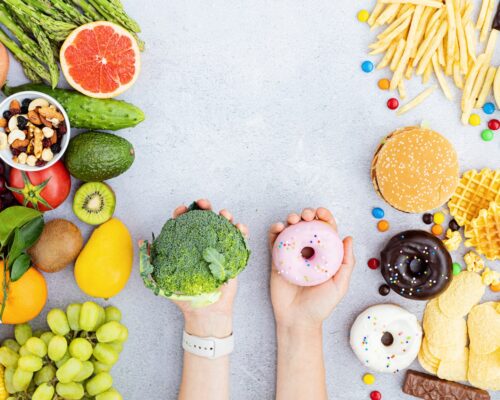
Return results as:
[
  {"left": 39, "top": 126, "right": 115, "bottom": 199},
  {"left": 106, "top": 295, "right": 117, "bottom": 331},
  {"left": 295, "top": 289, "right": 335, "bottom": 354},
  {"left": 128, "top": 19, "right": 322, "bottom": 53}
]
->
[{"left": 371, "top": 127, "right": 459, "bottom": 213}]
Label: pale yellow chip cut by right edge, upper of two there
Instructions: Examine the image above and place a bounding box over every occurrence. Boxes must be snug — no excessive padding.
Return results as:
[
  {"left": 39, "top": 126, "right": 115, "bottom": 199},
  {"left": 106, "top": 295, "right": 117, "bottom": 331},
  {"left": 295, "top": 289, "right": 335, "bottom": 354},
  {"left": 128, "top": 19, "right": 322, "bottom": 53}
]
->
[{"left": 467, "top": 301, "right": 500, "bottom": 354}]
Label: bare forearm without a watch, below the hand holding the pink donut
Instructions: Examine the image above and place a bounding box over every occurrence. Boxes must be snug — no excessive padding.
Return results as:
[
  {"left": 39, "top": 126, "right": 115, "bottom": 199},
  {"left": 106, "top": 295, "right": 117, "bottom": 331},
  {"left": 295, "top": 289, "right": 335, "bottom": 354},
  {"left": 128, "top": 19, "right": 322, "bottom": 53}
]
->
[{"left": 276, "top": 325, "right": 328, "bottom": 400}]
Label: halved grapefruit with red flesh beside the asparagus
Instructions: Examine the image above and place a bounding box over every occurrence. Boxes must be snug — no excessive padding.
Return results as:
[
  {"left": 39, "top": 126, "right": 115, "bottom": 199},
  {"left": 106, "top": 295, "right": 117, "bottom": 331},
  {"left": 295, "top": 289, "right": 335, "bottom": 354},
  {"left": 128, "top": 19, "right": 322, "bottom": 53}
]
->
[{"left": 60, "top": 21, "right": 141, "bottom": 98}]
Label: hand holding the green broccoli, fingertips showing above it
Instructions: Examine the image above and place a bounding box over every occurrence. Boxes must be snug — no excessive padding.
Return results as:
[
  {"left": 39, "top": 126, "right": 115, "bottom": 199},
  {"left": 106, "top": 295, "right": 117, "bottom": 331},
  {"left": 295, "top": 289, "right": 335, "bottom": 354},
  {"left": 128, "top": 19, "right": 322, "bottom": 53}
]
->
[{"left": 172, "top": 199, "right": 248, "bottom": 338}]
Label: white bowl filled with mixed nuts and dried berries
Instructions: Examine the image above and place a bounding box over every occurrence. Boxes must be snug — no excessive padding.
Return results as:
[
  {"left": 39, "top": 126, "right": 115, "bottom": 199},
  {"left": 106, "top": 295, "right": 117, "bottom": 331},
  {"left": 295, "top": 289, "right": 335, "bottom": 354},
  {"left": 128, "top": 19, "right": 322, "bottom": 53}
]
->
[{"left": 0, "top": 92, "right": 71, "bottom": 171}]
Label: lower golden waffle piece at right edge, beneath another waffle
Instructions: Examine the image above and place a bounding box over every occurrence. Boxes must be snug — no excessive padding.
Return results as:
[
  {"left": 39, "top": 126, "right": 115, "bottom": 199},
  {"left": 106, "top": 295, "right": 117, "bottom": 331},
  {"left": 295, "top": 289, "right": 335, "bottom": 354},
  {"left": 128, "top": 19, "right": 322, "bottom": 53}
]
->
[{"left": 465, "top": 201, "right": 500, "bottom": 260}]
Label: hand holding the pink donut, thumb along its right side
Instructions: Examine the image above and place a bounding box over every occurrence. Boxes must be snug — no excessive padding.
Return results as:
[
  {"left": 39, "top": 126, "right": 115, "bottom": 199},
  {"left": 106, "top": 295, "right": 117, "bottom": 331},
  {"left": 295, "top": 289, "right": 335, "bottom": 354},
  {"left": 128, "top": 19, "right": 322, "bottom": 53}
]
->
[{"left": 269, "top": 208, "right": 355, "bottom": 329}]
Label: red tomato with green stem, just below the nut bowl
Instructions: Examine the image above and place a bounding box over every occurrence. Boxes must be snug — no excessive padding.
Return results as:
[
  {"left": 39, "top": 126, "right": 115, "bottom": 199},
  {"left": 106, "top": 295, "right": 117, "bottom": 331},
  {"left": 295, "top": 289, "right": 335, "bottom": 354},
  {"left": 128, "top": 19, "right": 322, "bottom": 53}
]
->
[{"left": 9, "top": 161, "right": 71, "bottom": 211}]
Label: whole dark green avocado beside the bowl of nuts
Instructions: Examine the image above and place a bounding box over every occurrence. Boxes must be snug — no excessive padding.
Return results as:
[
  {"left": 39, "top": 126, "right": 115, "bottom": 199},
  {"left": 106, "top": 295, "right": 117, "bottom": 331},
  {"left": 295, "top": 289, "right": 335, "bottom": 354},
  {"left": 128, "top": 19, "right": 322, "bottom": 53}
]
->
[{"left": 65, "top": 131, "right": 135, "bottom": 182}]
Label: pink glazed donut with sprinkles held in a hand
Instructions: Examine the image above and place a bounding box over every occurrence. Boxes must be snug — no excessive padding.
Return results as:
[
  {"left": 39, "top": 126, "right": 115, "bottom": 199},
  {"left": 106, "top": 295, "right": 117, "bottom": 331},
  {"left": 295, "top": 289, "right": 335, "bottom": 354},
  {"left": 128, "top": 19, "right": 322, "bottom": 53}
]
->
[{"left": 273, "top": 220, "right": 344, "bottom": 286}]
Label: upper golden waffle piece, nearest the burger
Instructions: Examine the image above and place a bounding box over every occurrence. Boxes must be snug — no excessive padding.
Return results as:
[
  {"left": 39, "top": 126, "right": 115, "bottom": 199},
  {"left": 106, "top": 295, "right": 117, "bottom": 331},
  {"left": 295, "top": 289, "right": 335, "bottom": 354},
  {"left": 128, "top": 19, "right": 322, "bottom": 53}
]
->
[{"left": 448, "top": 168, "right": 500, "bottom": 226}]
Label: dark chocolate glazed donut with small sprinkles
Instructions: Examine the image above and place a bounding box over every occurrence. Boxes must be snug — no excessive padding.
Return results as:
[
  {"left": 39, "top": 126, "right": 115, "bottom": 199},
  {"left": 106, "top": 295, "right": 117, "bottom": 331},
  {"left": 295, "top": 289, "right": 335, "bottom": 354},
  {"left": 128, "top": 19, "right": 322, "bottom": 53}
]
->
[{"left": 380, "top": 231, "right": 452, "bottom": 300}]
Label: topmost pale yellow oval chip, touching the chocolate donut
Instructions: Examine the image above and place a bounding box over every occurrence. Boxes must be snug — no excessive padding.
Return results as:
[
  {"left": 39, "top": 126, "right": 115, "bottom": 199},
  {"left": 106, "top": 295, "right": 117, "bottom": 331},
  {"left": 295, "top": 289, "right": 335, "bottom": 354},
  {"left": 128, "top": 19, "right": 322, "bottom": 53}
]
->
[{"left": 438, "top": 271, "right": 485, "bottom": 318}]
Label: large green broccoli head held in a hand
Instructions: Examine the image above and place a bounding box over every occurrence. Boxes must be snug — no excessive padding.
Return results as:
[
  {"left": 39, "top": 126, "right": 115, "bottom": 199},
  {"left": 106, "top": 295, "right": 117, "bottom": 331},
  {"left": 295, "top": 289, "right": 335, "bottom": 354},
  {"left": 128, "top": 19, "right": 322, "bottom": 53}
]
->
[{"left": 141, "top": 210, "right": 250, "bottom": 304}]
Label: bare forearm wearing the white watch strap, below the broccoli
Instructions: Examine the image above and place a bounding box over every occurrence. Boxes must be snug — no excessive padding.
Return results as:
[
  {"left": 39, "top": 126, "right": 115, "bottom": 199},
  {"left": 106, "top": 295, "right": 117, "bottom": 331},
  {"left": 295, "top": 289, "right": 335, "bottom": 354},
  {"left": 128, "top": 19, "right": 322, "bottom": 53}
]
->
[{"left": 179, "top": 316, "right": 232, "bottom": 400}]
